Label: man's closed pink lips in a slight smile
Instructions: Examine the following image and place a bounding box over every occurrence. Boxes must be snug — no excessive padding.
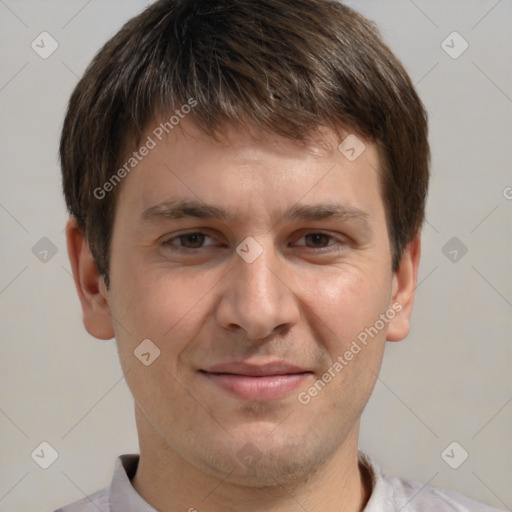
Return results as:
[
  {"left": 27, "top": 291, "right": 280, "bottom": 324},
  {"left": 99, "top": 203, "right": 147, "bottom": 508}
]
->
[{"left": 200, "top": 361, "right": 312, "bottom": 402}]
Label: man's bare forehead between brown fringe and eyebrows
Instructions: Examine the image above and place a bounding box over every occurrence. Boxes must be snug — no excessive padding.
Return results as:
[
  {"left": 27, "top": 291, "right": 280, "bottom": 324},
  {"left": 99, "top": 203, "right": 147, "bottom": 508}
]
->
[{"left": 113, "top": 119, "right": 380, "bottom": 225}]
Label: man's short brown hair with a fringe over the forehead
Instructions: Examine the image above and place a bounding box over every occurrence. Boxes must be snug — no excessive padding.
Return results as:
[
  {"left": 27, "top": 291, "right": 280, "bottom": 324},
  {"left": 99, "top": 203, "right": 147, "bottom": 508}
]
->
[{"left": 60, "top": 0, "right": 430, "bottom": 286}]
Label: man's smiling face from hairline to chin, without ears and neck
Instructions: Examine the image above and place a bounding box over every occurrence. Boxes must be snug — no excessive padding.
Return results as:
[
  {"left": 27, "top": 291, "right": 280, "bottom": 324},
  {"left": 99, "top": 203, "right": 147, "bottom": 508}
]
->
[{"left": 81, "top": 119, "right": 416, "bottom": 485}]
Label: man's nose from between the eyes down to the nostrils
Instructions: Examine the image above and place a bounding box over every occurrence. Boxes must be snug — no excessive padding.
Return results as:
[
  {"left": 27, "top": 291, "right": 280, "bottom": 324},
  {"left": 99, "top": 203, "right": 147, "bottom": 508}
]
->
[{"left": 216, "top": 240, "right": 300, "bottom": 340}]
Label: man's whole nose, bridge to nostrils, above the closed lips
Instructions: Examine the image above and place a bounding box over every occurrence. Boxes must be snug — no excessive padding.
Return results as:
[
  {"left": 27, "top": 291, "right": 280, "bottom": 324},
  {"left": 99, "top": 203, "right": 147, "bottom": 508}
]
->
[{"left": 214, "top": 237, "right": 299, "bottom": 339}]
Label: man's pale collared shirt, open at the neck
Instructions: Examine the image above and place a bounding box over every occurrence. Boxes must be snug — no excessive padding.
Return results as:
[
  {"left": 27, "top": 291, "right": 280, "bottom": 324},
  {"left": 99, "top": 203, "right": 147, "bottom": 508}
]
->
[{"left": 55, "top": 451, "right": 504, "bottom": 512}]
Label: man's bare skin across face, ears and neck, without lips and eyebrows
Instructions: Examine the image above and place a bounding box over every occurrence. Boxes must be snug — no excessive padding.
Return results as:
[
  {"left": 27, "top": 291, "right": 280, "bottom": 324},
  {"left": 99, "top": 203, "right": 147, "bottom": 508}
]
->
[{"left": 66, "top": 119, "right": 420, "bottom": 512}]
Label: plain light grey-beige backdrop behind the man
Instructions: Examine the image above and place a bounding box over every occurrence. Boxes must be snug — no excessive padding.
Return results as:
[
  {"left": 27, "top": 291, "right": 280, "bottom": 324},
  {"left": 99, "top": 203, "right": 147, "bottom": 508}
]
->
[{"left": 0, "top": 0, "right": 512, "bottom": 512}]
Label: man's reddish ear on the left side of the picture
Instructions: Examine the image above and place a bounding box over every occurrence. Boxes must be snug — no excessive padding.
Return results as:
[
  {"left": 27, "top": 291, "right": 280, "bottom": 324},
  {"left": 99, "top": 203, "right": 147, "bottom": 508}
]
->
[{"left": 66, "top": 217, "right": 114, "bottom": 340}]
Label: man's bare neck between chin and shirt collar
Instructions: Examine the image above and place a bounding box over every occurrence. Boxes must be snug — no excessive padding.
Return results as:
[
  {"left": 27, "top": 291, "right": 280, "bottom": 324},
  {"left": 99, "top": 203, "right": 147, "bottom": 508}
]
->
[{"left": 132, "top": 411, "right": 371, "bottom": 512}]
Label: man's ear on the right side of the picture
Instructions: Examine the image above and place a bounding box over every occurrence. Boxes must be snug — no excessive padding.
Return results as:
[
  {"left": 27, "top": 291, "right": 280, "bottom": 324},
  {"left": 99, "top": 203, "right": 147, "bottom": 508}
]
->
[{"left": 386, "top": 232, "right": 421, "bottom": 341}]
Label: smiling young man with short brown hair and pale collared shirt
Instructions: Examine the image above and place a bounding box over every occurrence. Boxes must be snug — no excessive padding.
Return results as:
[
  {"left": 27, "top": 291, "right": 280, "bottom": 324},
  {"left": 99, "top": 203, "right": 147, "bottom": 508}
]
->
[{"left": 55, "top": 0, "right": 500, "bottom": 512}]
